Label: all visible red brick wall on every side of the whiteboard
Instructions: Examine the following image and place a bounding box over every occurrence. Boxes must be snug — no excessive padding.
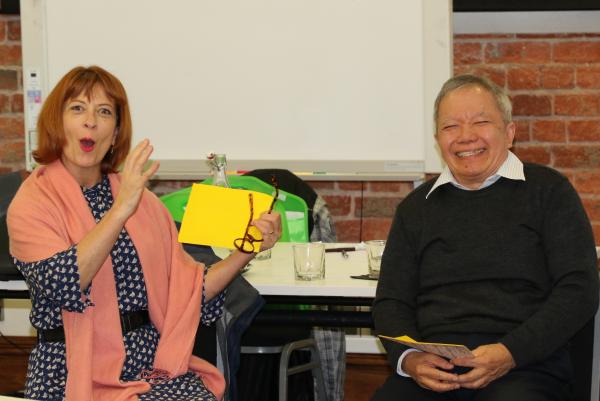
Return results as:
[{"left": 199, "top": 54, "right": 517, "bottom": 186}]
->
[{"left": 0, "top": 15, "right": 600, "bottom": 244}]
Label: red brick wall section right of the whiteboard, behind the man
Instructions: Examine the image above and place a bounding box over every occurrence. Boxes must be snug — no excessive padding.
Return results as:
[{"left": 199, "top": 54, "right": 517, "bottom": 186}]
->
[{"left": 454, "top": 34, "right": 600, "bottom": 243}]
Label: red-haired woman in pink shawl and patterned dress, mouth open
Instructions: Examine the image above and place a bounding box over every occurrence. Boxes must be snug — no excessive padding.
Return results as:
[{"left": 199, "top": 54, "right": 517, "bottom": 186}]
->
[{"left": 8, "top": 66, "right": 281, "bottom": 401}]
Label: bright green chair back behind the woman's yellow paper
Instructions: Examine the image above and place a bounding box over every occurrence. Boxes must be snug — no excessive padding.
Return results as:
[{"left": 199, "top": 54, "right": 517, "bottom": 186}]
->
[{"left": 160, "top": 176, "right": 309, "bottom": 242}]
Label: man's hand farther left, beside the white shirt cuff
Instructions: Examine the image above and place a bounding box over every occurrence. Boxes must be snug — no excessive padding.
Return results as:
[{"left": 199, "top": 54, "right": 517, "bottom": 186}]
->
[{"left": 401, "top": 352, "right": 460, "bottom": 393}]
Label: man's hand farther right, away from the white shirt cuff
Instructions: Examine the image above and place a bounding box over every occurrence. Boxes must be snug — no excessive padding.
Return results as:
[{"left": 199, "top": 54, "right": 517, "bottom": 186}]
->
[{"left": 451, "top": 343, "right": 516, "bottom": 389}]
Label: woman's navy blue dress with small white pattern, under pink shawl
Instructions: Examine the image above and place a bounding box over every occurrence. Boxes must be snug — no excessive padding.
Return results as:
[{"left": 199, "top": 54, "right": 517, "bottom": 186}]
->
[{"left": 15, "top": 176, "right": 225, "bottom": 401}]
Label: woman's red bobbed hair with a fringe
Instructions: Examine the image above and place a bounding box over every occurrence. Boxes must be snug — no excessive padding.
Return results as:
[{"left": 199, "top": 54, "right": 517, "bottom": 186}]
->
[{"left": 33, "top": 66, "right": 132, "bottom": 173}]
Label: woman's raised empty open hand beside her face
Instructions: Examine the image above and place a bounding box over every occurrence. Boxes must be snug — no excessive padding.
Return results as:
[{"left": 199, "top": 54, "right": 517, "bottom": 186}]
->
[{"left": 114, "top": 139, "right": 159, "bottom": 219}]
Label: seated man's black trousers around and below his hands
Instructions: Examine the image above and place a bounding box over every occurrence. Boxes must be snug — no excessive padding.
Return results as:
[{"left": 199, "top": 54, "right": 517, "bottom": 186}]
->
[{"left": 371, "top": 335, "right": 573, "bottom": 401}]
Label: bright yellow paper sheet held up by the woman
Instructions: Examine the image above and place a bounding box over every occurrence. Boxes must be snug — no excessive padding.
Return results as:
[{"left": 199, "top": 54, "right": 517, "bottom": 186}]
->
[{"left": 179, "top": 184, "right": 273, "bottom": 250}]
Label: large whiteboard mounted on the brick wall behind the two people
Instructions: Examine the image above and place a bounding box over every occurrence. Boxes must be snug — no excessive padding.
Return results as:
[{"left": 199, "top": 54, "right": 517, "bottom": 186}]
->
[{"left": 21, "top": 0, "right": 451, "bottom": 178}]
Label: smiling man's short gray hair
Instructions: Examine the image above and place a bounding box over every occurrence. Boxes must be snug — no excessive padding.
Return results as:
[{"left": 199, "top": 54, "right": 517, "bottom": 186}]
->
[{"left": 433, "top": 74, "right": 512, "bottom": 133}]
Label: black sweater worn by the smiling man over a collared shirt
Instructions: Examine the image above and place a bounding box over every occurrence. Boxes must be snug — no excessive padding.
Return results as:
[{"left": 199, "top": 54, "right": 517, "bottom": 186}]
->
[{"left": 373, "top": 164, "right": 598, "bottom": 370}]
